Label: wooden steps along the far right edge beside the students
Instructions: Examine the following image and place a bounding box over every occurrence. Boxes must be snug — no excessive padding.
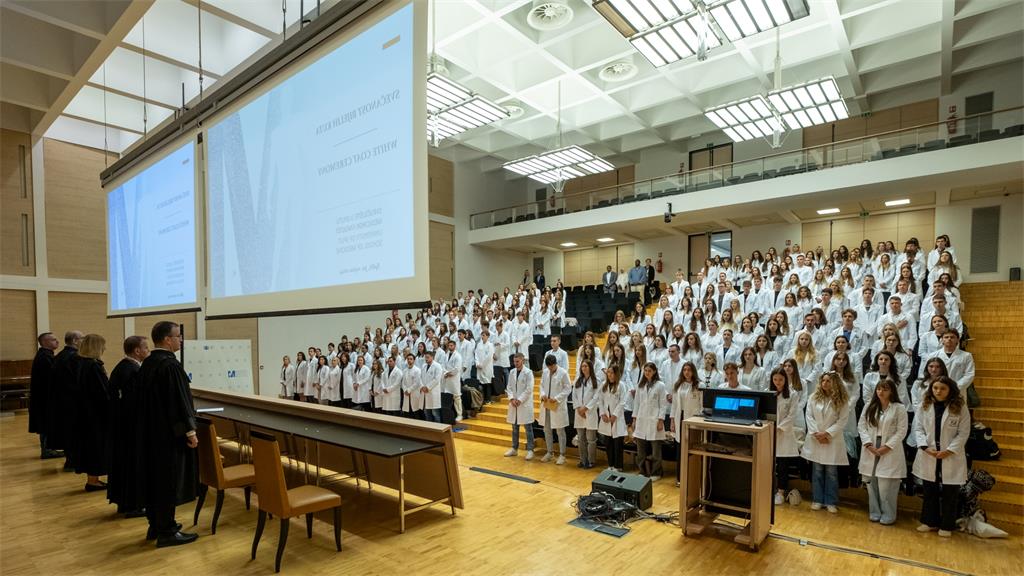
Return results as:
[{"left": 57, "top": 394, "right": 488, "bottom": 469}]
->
[{"left": 961, "top": 282, "right": 1024, "bottom": 536}]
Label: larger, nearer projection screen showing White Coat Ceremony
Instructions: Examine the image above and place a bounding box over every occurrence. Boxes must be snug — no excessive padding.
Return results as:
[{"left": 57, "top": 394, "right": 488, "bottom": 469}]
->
[{"left": 204, "top": 0, "right": 430, "bottom": 318}]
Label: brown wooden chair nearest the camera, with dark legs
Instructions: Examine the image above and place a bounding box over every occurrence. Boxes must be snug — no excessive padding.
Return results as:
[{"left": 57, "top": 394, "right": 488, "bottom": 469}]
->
[{"left": 250, "top": 430, "right": 341, "bottom": 572}]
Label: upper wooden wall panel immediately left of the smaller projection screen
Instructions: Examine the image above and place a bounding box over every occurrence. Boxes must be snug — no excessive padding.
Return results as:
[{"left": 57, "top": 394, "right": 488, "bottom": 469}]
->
[{"left": 43, "top": 138, "right": 117, "bottom": 280}]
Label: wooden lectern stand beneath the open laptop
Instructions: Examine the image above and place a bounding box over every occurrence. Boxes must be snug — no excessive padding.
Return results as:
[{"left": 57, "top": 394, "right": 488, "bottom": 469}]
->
[{"left": 679, "top": 416, "right": 775, "bottom": 550}]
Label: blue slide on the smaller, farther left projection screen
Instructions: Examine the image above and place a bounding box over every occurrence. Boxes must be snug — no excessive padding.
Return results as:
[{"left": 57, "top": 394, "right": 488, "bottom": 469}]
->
[{"left": 106, "top": 141, "right": 197, "bottom": 314}]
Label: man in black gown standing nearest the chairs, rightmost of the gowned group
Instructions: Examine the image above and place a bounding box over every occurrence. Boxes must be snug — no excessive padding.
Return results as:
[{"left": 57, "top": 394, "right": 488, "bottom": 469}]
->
[{"left": 137, "top": 321, "right": 199, "bottom": 547}]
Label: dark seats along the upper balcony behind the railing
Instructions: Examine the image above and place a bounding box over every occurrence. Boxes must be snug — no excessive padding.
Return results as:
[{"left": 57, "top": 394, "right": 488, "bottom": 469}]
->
[{"left": 495, "top": 124, "right": 1024, "bottom": 225}]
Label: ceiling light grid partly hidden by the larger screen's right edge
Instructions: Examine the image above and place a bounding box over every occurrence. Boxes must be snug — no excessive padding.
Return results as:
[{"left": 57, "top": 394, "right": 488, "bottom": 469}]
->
[{"left": 427, "top": 72, "right": 509, "bottom": 141}]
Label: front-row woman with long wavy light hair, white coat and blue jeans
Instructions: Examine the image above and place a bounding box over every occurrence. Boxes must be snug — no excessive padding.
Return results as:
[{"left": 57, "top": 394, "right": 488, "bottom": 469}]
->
[{"left": 802, "top": 372, "right": 850, "bottom": 513}]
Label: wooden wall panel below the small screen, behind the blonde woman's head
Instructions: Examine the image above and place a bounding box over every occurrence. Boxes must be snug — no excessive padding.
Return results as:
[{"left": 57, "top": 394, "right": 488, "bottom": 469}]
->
[{"left": 49, "top": 292, "right": 123, "bottom": 372}]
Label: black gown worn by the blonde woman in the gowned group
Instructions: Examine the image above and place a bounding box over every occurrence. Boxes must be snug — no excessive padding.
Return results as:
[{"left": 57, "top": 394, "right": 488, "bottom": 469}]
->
[{"left": 74, "top": 356, "right": 111, "bottom": 476}]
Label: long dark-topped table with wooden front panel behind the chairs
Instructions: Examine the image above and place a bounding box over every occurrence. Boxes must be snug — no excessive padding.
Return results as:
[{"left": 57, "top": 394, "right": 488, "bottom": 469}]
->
[{"left": 193, "top": 386, "right": 463, "bottom": 533}]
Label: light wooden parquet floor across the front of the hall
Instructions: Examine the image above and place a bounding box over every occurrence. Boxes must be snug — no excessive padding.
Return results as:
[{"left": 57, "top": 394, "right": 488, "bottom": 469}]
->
[{"left": 0, "top": 415, "right": 1024, "bottom": 576}]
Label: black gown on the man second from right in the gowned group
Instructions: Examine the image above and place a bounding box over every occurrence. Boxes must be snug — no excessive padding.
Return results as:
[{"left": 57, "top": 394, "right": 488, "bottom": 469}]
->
[{"left": 106, "top": 358, "right": 142, "bottom": 510}]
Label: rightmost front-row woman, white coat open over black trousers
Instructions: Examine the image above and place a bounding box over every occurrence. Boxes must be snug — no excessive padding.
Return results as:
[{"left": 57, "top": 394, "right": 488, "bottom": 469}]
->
[{"left": 913, "top": 378, "right": 971, "bottom": 538}]
